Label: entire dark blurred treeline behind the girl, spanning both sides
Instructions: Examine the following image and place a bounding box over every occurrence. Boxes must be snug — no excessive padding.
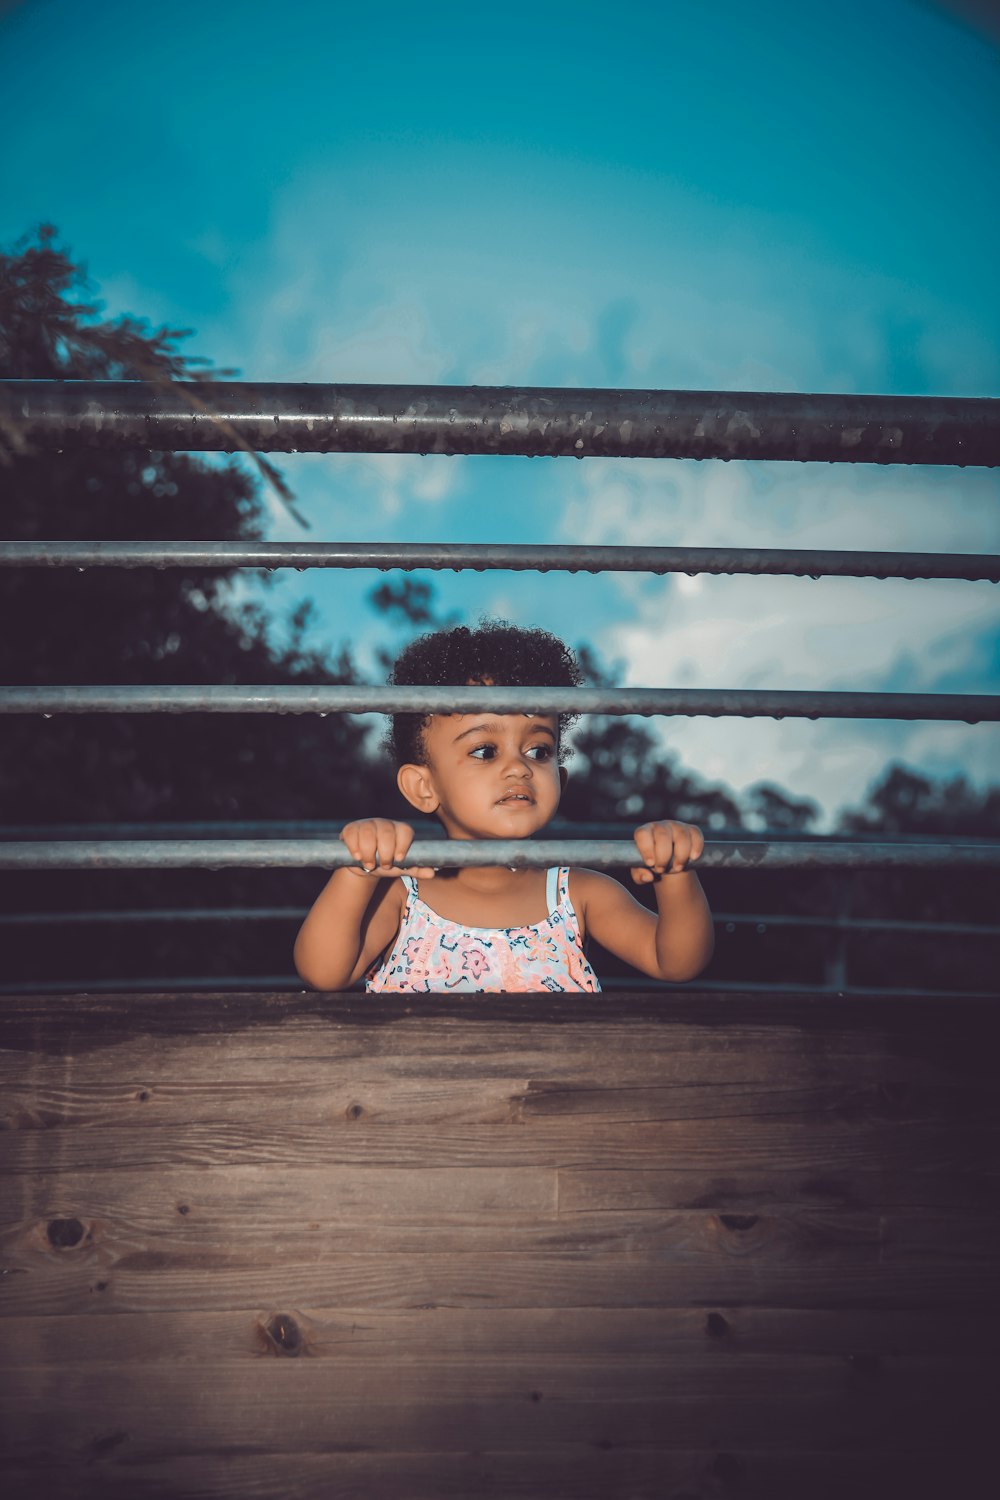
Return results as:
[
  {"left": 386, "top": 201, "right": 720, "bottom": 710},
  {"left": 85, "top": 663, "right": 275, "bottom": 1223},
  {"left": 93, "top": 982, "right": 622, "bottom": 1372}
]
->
[{"left": 0, "top": 228, "right": 1000, "bottom": 990}]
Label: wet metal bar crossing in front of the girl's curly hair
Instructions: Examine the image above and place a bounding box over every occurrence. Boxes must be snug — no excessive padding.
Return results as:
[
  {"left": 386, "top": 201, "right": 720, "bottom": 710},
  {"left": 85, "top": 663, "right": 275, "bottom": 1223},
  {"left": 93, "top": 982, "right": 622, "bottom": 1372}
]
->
[{"left": 0, "top": 683, "right": 1000, "bottom": 725}]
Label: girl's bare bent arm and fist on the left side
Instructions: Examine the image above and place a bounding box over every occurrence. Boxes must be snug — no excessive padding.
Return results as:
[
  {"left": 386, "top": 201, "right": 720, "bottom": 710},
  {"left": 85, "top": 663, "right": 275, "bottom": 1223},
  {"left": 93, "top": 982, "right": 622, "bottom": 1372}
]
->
[{"left": 294, "top": 818, "right": 433, "bottom": 990}]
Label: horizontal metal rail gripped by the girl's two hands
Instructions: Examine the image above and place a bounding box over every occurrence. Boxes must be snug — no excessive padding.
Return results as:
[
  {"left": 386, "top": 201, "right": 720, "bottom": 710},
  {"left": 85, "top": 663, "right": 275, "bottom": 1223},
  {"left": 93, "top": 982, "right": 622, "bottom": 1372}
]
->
[{"left": 0, "top": 839, "right": 1000, "bottom": 870}]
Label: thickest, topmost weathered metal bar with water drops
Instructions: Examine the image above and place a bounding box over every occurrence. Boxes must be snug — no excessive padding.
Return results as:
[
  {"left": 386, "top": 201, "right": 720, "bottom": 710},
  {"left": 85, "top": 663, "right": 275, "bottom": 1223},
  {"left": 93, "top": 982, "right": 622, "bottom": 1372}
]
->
[{"left": 0, "top": 381, "right": 1000, "bottom": 465}]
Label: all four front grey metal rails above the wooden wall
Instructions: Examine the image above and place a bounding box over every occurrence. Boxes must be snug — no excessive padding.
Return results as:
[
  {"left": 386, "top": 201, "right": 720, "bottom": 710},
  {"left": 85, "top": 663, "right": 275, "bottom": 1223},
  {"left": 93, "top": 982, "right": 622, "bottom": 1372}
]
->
[{"left": 0, "top": 381, "right": 1000, "bottom": 900}]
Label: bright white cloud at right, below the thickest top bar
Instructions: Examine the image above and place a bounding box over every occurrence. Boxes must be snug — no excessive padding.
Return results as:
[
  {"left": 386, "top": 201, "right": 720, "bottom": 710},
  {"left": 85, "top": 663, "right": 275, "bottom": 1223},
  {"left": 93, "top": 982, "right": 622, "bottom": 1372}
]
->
[{"left": 562, "top": 461, "right": 1000, "bottom": 813}]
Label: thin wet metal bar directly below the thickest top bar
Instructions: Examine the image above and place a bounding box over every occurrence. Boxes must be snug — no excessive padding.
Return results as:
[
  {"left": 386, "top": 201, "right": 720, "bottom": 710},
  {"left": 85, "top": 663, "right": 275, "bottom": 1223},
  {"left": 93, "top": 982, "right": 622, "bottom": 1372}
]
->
[{"left": 0, "top": 540, "right": 1000, "bottom": 584}]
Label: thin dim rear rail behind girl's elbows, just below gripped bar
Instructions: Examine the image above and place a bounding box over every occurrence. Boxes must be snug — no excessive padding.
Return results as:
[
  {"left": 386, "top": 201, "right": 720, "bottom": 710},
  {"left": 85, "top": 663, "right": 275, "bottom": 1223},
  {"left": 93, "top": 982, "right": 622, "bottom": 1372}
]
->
[{"left": 0, "top": 906, "right": 1000, "bottom": 938}]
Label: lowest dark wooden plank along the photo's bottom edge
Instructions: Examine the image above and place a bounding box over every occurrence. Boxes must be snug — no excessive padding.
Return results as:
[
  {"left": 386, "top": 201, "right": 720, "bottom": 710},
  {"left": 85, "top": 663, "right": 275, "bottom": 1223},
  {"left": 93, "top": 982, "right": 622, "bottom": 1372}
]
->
[{"left": 4, "top": 1430, "right": 988, "bottom": 1500}]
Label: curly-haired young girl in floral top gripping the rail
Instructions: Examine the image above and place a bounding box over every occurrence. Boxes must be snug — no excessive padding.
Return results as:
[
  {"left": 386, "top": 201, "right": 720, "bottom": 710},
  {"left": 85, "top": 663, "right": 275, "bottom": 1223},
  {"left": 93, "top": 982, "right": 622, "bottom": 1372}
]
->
[{"left": 295, "top": 621, "right": 714, "bottom": 993}]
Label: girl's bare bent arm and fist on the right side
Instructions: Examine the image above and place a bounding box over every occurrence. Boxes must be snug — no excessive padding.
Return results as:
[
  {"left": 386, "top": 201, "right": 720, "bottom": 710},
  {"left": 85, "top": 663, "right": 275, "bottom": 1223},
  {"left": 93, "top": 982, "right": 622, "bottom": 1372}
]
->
[{"left": 574, "top": 824, "right": 715, "bottom": 981}]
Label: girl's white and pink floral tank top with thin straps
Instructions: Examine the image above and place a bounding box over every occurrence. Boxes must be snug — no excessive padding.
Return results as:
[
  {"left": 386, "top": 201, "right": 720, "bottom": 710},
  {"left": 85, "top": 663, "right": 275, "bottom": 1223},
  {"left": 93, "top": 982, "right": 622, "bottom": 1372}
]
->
[{"left": 364, "top": 869, "right": 601, "bottom": 995}]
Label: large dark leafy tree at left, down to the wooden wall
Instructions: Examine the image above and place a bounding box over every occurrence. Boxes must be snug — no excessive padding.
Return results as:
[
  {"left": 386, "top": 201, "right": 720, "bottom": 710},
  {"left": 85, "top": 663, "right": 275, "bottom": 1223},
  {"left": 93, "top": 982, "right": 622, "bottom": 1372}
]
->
[{"left": 0, "top": 228, "right": 388, "bottom": 981}]
